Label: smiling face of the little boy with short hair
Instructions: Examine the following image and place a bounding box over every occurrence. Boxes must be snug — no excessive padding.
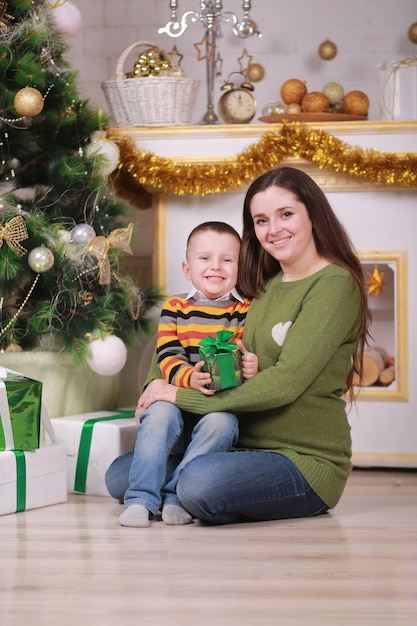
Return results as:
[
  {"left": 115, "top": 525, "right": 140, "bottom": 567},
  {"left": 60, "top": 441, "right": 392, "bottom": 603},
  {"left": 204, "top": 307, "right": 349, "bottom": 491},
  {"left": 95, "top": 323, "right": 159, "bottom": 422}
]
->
[{"left": 182, "top": 230, "right": 240, "bottom": 300}]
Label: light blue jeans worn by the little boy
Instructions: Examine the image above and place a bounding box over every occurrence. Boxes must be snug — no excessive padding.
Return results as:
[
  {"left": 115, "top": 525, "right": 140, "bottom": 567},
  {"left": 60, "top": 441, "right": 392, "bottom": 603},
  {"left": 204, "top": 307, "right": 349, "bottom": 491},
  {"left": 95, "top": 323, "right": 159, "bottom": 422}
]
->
[{"left": 119, "top": 402, "right": 239, "bottom": 515}]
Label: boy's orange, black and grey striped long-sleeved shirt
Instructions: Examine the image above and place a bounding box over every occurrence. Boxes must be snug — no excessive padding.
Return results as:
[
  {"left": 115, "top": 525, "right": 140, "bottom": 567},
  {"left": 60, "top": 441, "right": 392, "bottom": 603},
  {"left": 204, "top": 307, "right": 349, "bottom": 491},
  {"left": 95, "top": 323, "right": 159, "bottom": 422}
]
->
[{"left": 156, "top": 289, "right": 250, "bottom": 388}]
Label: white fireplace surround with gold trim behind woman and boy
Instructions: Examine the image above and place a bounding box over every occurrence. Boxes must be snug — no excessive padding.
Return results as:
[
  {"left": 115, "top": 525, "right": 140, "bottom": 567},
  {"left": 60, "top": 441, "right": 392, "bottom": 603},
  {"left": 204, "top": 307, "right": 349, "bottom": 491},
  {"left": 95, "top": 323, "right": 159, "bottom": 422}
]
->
[{"left": 109, "top": 122, "right": 417, "bottom": 467}]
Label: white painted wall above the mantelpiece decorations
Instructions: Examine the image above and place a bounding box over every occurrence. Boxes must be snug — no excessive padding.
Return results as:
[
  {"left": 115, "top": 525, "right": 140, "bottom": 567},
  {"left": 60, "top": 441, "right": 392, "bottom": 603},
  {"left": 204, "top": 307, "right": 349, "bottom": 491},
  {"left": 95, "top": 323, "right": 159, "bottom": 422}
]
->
[{"left": 69, "top": 0, "right": 417, "bottom": 123}]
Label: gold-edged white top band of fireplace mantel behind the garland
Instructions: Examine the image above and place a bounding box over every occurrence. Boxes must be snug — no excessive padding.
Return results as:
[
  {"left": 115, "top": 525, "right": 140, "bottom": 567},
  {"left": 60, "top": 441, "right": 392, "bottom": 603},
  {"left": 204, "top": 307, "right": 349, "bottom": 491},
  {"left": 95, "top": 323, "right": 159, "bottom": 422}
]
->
[{"left": 109, "top": 121, "right": 417, "bottom": 191}]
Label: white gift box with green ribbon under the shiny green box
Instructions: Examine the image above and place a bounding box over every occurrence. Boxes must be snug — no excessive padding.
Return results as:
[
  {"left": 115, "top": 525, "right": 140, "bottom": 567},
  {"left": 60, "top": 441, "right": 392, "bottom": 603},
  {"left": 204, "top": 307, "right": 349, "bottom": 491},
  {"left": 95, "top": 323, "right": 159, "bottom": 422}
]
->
[{"left": 0, "top": 443, "right": 67, "bottom": 515}]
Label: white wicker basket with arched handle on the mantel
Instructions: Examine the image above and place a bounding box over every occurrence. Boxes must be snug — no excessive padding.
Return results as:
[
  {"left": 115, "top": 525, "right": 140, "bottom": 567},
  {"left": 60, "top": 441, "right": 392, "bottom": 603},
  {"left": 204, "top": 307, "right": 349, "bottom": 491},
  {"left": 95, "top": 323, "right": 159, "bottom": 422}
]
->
[{"left": 101, "top": 41, "right": 200, "bottom": 127}]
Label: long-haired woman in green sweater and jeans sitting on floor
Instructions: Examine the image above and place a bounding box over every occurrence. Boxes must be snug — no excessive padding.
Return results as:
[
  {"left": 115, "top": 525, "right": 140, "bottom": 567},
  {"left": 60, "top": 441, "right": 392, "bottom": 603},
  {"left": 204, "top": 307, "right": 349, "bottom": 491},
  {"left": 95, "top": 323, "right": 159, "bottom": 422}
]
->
[{"left": 105, "top": 167, "right": 370, "bottom": 524}]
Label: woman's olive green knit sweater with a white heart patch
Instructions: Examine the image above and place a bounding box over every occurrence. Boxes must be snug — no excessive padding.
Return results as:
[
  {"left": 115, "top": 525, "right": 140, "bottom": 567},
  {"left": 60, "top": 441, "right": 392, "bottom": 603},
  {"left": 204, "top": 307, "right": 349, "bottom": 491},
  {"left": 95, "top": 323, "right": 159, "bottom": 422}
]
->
[{"left": 147, "top": 264, "right": 360, "bottom": 508}]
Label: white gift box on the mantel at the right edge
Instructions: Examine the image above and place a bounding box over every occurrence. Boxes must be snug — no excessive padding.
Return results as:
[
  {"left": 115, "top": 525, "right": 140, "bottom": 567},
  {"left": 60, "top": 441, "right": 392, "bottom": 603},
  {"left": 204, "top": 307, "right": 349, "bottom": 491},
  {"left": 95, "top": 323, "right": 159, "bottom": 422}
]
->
[{"left": 378, "top": 56, "right": 417, "bottom": 120}]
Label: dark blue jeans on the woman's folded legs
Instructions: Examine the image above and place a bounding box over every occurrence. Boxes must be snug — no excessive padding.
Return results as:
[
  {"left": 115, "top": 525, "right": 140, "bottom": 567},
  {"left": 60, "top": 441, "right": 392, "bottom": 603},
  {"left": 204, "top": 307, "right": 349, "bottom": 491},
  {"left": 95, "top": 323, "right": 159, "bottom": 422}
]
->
[{"left": 177, "top": 450, "right": 328, "bottom": 524}]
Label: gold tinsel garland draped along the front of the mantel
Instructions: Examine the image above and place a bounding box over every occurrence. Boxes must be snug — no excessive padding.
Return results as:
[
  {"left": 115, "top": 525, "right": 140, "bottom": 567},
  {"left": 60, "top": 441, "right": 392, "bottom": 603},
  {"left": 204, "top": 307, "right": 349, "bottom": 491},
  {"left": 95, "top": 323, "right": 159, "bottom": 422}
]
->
[{"left": 112, "top": 122, "right": 417, "bottom": 202}]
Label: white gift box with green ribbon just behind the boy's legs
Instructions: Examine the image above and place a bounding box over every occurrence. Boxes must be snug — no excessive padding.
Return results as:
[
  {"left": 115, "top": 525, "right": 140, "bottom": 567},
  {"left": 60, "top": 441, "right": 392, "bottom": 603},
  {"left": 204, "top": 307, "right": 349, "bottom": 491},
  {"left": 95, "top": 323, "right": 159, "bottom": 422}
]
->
[{"left": 53, "top": 409, "right": 138, "bottom": 496}]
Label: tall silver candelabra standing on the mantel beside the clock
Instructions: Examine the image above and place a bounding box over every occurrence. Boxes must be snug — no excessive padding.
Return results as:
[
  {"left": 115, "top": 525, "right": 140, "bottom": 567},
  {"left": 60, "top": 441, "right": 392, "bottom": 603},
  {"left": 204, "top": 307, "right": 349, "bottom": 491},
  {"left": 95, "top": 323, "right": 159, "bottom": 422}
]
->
[{"left": 158, "top": 0, "right": 262, "bottom": 124}]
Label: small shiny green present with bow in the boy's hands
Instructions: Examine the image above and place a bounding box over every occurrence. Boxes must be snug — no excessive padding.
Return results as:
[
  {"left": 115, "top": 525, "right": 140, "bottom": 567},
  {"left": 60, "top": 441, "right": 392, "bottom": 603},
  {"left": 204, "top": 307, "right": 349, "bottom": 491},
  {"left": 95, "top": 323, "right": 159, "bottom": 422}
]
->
[{"left": 199, "top": 330, "right": 243, "bottom": 391}]
